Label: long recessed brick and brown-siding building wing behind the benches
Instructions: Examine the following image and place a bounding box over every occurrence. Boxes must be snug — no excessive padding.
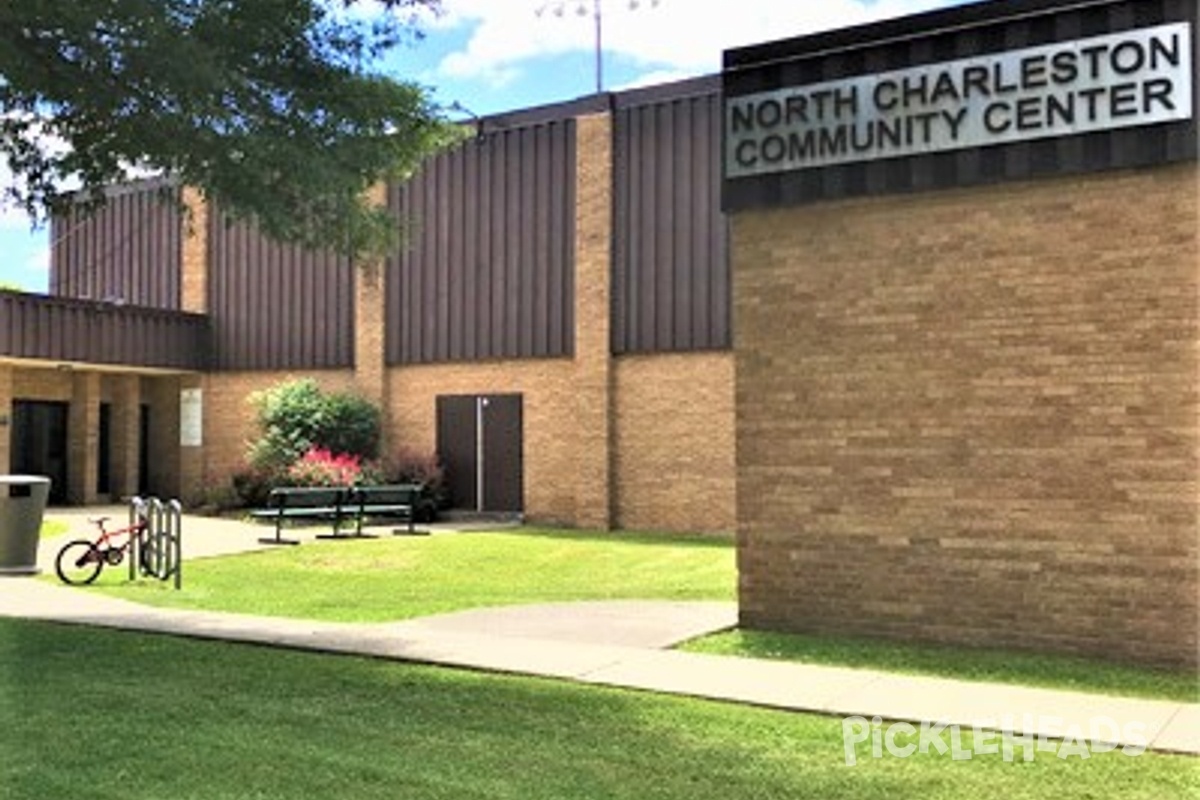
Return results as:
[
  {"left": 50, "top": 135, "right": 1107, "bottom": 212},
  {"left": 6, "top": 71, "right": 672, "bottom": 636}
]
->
[{"left": 0, "top": 77, "right": 734, "bottom": 531}]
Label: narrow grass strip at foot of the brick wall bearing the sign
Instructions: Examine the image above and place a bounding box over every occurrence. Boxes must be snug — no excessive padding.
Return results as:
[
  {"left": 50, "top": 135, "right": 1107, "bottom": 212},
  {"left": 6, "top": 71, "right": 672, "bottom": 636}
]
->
[{"left": 682, "top": 631, "right": 1200, "bottom": 703}]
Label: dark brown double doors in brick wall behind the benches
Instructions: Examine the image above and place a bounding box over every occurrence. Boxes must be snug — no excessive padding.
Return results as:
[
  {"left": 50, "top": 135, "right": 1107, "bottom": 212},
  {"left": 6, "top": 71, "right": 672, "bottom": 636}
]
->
[{"left": 437, "top": 395, "right": 524, "bottom": 512}]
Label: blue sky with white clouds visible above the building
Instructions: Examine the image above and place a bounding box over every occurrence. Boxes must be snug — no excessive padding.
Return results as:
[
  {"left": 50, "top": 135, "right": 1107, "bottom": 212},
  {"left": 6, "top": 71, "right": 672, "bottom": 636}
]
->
[{"left": 0, "top": 0, "right": 962, "bottom": 291}]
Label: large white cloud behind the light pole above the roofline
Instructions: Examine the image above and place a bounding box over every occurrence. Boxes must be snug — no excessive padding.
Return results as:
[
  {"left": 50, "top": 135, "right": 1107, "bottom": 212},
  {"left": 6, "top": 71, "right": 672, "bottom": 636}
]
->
[{"left": 433, "top": 0, "right": 948, "bottom": 85}]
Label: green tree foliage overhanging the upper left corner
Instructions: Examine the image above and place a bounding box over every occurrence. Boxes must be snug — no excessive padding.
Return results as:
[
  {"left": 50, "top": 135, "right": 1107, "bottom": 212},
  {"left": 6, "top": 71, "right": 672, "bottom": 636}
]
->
[{"left": 0, "top": 0, "right": 455, "bottom": 254}]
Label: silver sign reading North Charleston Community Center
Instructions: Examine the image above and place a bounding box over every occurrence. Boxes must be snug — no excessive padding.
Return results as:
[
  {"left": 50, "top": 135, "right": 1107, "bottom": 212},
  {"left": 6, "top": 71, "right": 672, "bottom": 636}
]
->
[{"left": 725, "top": 23, "right": 1194, "bottom": 178}]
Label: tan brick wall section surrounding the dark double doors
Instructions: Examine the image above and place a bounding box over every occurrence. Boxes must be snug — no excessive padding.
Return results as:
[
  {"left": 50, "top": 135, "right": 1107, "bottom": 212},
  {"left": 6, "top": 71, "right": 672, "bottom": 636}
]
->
[{"left": 388, "top": 360, "right": 587, "bottom": 524}]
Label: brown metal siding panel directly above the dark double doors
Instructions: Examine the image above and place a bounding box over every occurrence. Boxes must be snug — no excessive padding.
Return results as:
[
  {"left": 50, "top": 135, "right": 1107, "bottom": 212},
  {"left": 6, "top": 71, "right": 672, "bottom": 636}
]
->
[{"left": 386, "top": 120, "right": 575, "bottom": 365}]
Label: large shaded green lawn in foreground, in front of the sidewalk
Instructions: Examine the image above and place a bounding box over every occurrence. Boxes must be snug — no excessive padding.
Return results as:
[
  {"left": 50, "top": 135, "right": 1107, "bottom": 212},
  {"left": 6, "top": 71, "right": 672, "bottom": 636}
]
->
[{"left": 0, "top": 620, "right": 1200, "bottom": 800}]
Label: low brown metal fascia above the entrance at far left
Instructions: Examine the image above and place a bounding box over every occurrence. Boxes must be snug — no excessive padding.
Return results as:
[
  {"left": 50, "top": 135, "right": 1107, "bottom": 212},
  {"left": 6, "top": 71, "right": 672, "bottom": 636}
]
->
[{"left": 0, "top": 291, "right": 209, "bottom": 371}]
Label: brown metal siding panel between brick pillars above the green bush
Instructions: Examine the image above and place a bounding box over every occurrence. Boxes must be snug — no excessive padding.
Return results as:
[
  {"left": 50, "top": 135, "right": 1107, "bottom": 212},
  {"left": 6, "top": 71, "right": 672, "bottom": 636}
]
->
[{"left": 208, "top": 212, "right": 354, "bottom": 369}]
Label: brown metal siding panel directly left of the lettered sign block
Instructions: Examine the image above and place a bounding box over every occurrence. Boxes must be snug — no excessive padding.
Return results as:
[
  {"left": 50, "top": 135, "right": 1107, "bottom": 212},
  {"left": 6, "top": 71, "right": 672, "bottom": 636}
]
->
[{"left": 612, "top": 79, "right": 732, "bottom": 354}]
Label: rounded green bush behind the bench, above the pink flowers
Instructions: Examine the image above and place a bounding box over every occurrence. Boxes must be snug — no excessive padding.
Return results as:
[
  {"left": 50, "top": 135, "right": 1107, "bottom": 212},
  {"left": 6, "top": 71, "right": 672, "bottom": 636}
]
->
[{"left": 248, "top": 378, "right": 379, "bottom": 473}]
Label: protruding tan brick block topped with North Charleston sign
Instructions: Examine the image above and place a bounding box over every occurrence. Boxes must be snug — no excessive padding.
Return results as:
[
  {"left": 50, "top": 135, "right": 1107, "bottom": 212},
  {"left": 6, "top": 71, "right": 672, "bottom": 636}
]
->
[{"left": 724, "top": 0, "right": 1200, "bottom": 666}]
